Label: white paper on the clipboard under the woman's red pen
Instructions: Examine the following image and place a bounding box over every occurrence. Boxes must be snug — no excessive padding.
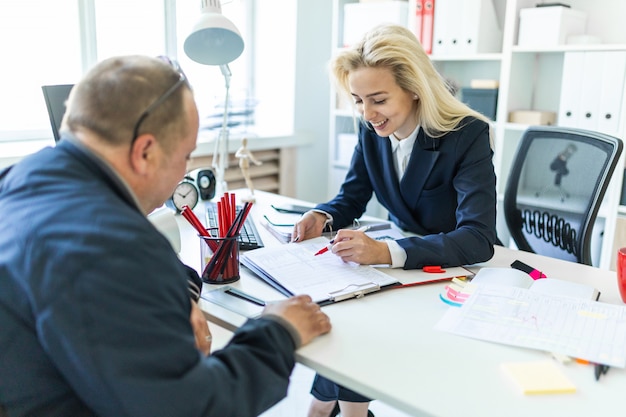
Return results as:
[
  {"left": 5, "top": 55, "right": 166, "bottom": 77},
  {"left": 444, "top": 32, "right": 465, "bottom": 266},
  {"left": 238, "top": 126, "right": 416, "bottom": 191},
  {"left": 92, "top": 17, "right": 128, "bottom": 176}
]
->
[{"left": 241, "top": 237, "right": 397, "bottom": 302}]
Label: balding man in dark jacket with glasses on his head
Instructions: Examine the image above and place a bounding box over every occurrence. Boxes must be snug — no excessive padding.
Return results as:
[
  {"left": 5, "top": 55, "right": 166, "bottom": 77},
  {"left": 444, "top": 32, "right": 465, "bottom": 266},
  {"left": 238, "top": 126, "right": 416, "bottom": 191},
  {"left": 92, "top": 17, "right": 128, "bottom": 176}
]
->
[{"left": 0, "top": 56, "right": 331, "bottom": 417}]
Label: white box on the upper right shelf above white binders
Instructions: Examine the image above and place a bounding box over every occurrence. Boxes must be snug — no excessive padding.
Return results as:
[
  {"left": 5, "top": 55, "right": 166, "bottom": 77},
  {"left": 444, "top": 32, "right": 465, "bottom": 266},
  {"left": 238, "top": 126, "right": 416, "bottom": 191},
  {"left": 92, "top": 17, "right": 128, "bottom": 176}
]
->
[{"left": 517, "top": 6, "right": 587, "bottom": 47}]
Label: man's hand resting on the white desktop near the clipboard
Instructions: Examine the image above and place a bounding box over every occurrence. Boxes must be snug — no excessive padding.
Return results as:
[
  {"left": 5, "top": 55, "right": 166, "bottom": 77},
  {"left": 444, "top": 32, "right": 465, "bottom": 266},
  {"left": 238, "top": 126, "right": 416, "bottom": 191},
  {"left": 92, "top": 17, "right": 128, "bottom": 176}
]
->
[{"left": 263, "top": 295, "right": 331, "bottom": 346}]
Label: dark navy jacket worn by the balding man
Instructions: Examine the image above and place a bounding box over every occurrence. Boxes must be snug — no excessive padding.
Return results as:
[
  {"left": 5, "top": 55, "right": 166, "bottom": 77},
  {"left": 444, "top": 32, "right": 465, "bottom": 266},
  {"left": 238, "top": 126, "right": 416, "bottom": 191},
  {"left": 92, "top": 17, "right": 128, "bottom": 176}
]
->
[{"left": 0, "top": 139, "right": 296, "bottom": 417}]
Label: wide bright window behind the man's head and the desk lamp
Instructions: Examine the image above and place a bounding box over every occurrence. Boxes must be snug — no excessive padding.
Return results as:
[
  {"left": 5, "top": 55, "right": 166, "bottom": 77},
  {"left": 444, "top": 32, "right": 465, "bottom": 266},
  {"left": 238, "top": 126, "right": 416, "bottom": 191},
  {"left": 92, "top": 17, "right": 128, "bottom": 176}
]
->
[{"left": 0, "top": 0, "right": 296, "bottom": 144}]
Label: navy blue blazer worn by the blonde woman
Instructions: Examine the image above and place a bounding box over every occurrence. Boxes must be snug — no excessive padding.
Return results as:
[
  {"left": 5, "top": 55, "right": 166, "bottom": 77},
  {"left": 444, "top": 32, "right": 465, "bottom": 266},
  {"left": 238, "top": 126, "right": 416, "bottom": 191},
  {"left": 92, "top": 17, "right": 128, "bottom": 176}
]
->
[{"left": 316, "top": 118, "right": 496, "bottom": 269}]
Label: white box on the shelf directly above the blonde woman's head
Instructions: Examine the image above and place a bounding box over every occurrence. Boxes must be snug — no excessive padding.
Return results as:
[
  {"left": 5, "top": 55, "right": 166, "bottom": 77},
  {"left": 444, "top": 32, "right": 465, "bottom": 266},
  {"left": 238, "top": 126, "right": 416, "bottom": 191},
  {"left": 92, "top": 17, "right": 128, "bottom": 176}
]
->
[{"left": 343, "top": 0, "right": 409, "bottom": 46}]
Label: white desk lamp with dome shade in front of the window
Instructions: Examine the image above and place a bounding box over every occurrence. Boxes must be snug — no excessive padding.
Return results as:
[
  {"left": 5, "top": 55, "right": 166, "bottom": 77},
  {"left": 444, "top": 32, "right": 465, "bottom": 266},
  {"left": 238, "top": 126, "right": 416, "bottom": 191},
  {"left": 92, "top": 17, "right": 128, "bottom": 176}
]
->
[{"left": 184, "top": 0, "right": 243, "bottom": 195}]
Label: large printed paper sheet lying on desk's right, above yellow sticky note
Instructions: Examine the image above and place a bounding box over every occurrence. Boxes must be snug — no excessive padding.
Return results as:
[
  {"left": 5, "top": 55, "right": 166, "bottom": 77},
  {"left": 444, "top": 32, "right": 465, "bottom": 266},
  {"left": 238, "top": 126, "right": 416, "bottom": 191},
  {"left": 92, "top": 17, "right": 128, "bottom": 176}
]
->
[{"left": 435, "top": 286, "right": 626, "bottom": 368}]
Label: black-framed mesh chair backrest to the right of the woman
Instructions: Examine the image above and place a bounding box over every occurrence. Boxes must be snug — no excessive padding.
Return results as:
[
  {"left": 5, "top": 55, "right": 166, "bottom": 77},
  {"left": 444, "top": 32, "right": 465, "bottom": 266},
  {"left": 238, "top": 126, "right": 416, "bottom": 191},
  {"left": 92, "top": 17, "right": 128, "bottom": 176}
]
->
[{"left": 504, "top": 126, "right": 623, "bottom": 265}]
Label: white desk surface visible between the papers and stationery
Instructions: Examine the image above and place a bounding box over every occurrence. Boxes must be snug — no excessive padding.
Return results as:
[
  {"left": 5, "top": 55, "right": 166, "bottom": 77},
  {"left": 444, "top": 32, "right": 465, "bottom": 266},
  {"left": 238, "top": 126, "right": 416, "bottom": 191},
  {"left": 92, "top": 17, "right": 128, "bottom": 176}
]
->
[{"left": 179, "top": 192, "right": 626, "bottom": 417}]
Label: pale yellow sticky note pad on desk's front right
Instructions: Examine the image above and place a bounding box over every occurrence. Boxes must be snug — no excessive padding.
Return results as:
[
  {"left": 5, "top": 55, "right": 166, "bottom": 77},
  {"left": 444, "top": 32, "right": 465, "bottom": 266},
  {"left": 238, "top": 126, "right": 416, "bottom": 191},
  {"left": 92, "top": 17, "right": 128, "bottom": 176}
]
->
[{"left": 502, "top": 361, "right": 576, "bottom": 395}]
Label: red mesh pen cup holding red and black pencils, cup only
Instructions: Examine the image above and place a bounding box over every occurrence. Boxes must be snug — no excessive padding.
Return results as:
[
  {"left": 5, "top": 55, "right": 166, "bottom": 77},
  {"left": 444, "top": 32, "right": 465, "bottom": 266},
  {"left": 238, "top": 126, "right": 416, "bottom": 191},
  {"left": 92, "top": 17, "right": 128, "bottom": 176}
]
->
[{"left": 200, "top": 236, "right": 239, "bottom": 284}]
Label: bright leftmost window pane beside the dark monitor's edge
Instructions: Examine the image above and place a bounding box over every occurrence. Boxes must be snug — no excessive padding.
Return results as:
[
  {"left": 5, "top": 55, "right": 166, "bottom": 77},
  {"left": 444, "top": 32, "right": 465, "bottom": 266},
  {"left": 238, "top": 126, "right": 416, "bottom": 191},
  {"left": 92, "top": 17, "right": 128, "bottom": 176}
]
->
[{"left": 0, "top": 0, "right": 81, "bottom": 139}]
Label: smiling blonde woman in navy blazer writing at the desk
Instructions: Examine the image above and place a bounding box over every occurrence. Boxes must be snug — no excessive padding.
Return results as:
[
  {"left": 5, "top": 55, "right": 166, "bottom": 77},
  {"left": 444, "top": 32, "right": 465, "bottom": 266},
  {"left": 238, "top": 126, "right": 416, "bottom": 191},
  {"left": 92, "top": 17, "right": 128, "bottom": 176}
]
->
[{"left": 293, "top": 25, "right": 496, "bottom": 417}]
